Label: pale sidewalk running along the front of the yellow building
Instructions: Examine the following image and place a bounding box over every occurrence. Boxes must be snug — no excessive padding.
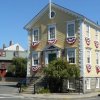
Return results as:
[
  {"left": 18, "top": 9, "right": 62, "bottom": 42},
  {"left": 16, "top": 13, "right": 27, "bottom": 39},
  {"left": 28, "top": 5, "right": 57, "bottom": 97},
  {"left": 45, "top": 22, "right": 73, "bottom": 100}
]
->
[{"left": 21, "top": 92, "right": 100, "bottom": 99}]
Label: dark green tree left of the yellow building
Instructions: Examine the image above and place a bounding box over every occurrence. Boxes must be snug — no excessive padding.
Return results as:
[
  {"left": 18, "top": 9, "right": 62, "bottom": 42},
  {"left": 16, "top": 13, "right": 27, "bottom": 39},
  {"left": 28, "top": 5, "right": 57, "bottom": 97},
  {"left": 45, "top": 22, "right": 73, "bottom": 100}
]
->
[{"left": 13, "top": 58, "right": 27, "bottom": 77}]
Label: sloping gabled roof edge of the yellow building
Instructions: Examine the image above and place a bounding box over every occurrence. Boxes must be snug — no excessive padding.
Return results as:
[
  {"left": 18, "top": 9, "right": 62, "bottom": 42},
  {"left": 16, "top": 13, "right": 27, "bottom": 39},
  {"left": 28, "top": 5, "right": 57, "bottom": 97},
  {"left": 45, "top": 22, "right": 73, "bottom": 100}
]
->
[{"left": 24, "top": 3, "right": 100, "bottom": 30}]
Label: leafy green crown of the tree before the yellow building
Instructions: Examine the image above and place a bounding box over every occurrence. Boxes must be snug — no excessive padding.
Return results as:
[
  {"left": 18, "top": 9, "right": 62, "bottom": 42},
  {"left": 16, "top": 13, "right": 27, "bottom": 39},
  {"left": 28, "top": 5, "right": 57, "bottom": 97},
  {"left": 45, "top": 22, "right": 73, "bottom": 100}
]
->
[{"left": 44, "top": 58, "right": 80, "bottom": 78}]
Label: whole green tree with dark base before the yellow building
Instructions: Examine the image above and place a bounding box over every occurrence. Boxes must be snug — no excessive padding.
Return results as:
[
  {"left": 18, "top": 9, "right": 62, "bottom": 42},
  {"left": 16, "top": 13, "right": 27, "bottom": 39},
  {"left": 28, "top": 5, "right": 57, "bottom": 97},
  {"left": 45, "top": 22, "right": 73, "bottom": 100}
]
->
[{"left": 44, "top": 58, "right": 80, "bottom": 92}]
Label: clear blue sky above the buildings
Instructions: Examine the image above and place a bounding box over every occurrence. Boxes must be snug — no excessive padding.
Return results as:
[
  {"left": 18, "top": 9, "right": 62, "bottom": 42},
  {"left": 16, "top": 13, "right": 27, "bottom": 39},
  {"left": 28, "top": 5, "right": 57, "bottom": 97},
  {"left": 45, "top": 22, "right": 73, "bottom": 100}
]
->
[{"left": 0, "top": 0, "right": 100, "bottom": 49}]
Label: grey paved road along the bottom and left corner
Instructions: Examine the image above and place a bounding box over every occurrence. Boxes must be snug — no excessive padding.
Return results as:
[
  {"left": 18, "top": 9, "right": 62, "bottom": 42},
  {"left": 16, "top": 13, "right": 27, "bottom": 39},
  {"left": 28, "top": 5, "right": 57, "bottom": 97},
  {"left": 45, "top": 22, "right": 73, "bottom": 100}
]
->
[{"left": 0, "top": 82, "right": 100, "bottom": 100}]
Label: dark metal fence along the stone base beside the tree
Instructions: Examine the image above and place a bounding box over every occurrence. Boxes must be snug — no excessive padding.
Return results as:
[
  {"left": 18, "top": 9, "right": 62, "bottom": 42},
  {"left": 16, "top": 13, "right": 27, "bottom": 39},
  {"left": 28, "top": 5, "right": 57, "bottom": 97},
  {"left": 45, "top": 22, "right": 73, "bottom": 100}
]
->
[{"left": 34, "top": 78, "right": 83, "bottom": 93}]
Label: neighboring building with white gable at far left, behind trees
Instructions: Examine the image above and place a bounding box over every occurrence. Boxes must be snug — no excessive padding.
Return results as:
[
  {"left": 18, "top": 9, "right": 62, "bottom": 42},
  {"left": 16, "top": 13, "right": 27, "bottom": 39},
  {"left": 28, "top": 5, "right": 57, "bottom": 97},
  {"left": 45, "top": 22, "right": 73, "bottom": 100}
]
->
[{"left": 0, "top": 43, "right": 27, "bottom": 77}]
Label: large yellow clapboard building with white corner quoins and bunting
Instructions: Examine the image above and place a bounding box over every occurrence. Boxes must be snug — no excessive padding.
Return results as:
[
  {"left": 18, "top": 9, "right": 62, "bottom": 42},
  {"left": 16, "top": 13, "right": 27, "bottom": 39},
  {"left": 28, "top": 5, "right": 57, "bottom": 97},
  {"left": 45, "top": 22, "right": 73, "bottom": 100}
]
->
[{"left": 25, "top": 3, "right": 100, "bottom": 93}]
